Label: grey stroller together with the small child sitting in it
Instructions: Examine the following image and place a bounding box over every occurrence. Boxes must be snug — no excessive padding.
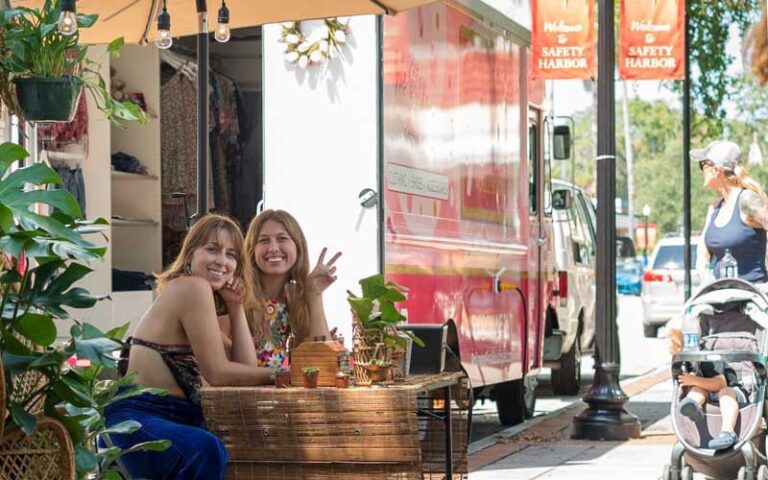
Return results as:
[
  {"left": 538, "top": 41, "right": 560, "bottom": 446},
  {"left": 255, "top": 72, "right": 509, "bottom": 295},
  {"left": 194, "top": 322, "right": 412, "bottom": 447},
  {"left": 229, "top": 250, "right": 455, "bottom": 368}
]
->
[{"left": 662, "top": 278, "right": 768, "bottom": 480}]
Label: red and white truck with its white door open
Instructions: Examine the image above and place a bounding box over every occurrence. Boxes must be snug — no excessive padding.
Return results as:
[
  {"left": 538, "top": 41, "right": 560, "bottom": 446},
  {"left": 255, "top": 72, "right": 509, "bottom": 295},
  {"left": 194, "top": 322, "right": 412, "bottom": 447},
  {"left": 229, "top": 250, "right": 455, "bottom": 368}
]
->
[{"left": 263, "top": 2, "right": 568, "bottom": 424}]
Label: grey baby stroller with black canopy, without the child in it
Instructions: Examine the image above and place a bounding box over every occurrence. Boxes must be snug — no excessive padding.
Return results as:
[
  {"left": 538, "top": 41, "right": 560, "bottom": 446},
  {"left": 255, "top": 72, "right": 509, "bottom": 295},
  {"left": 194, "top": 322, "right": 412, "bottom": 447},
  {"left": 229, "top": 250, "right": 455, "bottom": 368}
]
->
[{"left": 662, "top": 278, "right": 768, "bottom": 480}]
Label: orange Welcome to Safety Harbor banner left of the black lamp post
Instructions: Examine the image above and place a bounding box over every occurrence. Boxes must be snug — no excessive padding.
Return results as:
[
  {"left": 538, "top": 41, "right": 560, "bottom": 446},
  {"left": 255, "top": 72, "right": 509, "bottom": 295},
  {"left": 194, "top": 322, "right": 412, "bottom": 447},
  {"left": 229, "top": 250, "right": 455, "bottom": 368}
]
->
[{"left": 531, "top": 0, "right": 595, "bottom": 79}]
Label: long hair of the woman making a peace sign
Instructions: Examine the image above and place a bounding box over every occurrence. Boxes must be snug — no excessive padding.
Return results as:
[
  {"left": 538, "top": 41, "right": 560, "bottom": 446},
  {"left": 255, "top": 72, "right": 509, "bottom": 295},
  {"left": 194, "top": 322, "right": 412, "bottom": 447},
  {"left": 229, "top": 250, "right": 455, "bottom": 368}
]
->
[{"left": 244, "top": 210, "right": 309, "bottom": 340}]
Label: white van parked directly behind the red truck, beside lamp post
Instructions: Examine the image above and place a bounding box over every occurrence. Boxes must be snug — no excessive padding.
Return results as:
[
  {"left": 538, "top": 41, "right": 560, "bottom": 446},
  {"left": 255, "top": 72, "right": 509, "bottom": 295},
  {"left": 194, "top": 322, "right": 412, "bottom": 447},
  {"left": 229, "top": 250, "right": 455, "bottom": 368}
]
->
[{"left": 544, "top": 180, "right": 597, "bottom": 395}]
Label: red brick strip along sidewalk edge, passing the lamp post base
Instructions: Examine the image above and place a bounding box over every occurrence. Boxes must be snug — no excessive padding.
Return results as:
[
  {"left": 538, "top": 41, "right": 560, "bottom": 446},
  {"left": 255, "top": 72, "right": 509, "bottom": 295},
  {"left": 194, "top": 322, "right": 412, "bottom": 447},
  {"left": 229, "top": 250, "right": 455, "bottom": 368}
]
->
[{"left": 467, "top": 366, "right": 670, "bottom": 471}]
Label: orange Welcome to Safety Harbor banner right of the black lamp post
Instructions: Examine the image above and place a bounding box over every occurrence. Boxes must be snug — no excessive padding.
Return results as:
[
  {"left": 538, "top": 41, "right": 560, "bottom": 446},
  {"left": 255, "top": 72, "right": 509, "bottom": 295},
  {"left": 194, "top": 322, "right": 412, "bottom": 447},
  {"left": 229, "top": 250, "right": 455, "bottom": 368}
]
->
[{"left": 619, "top": 0, "right": 685, "bottom": 80}]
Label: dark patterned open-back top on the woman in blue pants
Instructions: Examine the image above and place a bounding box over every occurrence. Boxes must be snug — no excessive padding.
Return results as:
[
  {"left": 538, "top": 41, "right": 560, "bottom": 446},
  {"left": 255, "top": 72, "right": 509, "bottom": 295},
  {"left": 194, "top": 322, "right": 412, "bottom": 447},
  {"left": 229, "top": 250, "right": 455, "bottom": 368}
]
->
[{"left": 118, "top": 337, "right": 203, "bottom": 405}]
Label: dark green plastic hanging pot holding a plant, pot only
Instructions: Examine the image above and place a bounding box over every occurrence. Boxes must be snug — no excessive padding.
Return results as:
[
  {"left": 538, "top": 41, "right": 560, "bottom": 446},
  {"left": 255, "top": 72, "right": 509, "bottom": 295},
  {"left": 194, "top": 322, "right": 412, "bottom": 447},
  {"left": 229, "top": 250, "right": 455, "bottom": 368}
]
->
[{"left": 13, "top": 76, "right": 83, "bottom": 122}]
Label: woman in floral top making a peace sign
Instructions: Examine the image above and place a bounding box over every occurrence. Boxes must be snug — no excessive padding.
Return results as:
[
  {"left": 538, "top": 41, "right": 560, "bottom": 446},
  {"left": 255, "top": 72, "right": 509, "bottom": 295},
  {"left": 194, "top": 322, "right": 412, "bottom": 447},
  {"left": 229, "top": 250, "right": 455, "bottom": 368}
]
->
[{"left": 221, "top": 210, "right": 341, "bottom": 368}]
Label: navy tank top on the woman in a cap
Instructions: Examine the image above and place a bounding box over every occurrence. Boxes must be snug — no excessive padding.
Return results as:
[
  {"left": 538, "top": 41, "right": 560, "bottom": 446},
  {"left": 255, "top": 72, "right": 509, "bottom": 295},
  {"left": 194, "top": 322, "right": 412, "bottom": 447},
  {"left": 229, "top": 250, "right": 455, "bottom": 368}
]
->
[{"left": 704, "top": 190, "right": 768, "bottom": 282}]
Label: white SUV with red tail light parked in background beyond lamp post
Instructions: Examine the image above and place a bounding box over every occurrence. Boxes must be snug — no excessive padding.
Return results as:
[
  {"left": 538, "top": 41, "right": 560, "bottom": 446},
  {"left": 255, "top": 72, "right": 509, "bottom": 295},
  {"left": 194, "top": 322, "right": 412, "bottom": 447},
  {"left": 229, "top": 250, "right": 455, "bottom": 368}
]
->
[{"left": 642, "top": 237, "right": 699, "bottom": 337}]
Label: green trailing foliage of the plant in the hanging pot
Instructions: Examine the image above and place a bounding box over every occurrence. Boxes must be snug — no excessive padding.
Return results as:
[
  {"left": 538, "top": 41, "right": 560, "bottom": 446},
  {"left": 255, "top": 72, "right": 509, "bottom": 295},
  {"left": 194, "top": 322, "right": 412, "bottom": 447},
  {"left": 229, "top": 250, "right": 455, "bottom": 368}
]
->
[{"left": 0, "top": 0, "right": 148, "bottom": 125}]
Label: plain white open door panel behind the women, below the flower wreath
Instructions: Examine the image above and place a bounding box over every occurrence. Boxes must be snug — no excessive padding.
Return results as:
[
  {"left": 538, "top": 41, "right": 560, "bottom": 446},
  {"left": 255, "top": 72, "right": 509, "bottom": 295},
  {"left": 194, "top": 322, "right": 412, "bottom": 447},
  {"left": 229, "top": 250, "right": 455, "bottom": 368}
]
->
[{"left": 262, "top": 16, "right": 378, "bottom": 346}]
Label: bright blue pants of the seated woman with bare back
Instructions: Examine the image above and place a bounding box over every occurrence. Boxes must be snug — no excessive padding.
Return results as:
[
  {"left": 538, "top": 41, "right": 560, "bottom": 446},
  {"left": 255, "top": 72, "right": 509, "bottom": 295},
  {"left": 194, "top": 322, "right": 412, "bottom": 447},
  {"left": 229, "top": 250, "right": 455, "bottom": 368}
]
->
[{"left": 106, "top": 393, "right": 227, "bottom": 480}]
